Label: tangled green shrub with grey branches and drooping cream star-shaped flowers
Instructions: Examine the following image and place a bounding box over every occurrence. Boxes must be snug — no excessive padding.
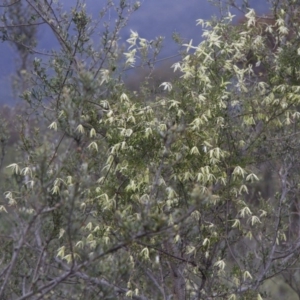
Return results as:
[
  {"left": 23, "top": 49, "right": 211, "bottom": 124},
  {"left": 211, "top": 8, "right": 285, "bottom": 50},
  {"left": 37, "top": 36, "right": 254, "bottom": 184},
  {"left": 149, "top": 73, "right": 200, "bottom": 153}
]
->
[{"left": 0, "top": 0, "right": 300, "bottom": 300}]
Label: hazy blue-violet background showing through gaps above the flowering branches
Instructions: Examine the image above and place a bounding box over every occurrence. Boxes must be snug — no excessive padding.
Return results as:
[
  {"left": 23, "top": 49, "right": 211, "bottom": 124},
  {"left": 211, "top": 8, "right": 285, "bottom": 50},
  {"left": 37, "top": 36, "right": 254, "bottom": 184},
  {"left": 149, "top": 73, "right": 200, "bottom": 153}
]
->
[{"left": 0, "top": 0, "right": 268, "bottom": 105}]
